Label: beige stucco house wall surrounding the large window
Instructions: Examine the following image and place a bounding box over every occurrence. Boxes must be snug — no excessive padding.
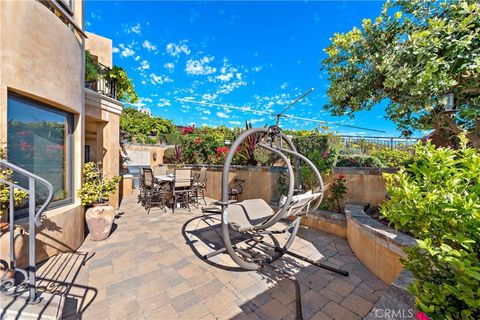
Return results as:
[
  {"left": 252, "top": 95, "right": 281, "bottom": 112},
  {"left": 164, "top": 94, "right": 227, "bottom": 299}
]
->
[{"left": 0, "top": 0, "right": 84, "bottom": 259}]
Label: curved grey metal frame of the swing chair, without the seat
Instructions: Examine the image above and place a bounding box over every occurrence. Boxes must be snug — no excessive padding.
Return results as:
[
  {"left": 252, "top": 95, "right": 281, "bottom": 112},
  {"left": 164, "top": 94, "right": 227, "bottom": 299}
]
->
[{"left": 204, "top": 125, "right": 348, "bottom": 276}]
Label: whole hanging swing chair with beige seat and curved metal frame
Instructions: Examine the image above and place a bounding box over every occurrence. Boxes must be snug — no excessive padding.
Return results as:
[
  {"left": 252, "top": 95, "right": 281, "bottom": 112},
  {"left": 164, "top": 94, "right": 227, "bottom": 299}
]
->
[{"left": 204, "top": 125, "right": 348, "bottom": 276}]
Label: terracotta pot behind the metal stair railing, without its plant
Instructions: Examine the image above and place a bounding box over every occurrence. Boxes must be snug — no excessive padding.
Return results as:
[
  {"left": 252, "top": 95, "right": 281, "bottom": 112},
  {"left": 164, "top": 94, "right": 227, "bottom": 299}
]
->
[{"left": 0, "top": 222, "right": 28, "bottom": 278}]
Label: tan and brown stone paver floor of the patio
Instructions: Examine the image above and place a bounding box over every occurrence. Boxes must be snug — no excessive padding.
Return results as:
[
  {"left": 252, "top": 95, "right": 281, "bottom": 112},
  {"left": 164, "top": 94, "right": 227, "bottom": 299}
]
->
[{"left": 39, "top": 194, "right": 387, "bottom": 320}]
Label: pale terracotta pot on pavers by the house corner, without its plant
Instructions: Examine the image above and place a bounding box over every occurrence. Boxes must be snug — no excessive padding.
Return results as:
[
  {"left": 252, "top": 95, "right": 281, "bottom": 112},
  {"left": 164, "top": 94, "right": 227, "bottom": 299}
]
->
[{"left": 85, "top": 204, "right": 115, "bottom": 241}]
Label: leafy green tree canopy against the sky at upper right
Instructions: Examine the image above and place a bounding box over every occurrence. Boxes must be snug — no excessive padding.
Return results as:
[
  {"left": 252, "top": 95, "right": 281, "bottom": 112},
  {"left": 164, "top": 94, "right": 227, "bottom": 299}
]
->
[{"left": 323, "top": 0, "right": 480, "bottom": 146}]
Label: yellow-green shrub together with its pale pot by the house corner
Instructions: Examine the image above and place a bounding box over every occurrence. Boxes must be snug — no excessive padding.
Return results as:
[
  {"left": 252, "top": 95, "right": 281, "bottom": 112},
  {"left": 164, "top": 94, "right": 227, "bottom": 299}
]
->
[{"left": 77, "top": 162, "right": 121, "bottom": 241}]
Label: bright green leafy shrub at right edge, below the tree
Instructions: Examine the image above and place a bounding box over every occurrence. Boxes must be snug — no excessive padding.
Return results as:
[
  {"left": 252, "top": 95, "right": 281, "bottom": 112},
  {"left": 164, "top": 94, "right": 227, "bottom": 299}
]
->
[{"left": 381, "top": 137, "right": 480, "bottom": 320}]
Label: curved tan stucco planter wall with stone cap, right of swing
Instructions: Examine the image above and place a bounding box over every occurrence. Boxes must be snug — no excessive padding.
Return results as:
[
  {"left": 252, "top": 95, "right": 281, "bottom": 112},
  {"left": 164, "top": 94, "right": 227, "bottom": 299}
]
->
[{"left": 302, "top": 204, "right": 417, "bottom": 320}]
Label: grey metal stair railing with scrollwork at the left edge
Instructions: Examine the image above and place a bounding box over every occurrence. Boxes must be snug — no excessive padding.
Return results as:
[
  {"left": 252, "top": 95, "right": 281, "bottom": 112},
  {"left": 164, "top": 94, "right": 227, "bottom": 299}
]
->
[{"left": 0, "top": 160, "right": 53, "bottom": 303}]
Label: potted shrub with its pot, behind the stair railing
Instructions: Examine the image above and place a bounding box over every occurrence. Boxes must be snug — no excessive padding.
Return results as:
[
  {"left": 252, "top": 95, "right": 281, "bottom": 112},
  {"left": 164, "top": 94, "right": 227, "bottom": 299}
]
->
[{"left": 0, "top": 148, "right": 28, "bottom": 277}]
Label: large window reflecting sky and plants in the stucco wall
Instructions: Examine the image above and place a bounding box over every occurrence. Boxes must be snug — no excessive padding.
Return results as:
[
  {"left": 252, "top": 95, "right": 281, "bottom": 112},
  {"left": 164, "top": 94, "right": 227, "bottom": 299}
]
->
[{"left": 7, "top": 93, "right": 73, "bottom": 212}]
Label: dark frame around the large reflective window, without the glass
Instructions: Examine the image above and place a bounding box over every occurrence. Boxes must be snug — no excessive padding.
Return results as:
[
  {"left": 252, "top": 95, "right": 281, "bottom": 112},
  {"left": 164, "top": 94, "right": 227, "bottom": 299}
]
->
[{"left": 6, "top": 91, "right": 75, "bottom": 219}]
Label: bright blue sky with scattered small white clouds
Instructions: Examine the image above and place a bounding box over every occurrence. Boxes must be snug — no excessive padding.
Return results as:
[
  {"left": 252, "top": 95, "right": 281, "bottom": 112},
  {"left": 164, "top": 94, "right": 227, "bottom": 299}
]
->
[{"left": 85, "top": 1, "right": 414, "bottom": 136}]
